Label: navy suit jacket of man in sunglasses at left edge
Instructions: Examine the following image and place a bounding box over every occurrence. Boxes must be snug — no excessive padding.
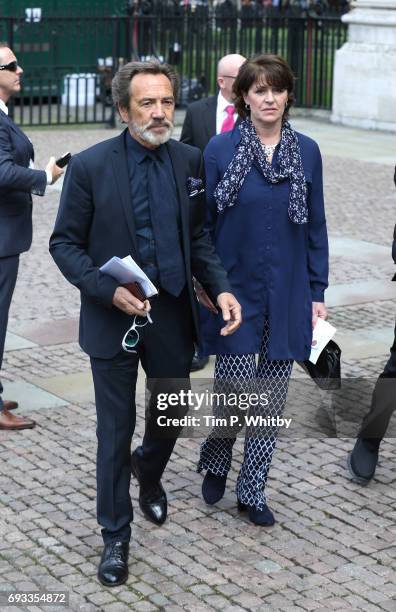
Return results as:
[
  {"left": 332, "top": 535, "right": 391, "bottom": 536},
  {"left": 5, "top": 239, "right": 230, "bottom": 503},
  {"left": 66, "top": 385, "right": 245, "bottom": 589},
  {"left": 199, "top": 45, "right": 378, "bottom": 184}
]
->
[{"left": 0, "top": 110, "right": 47, "bottom": 257}]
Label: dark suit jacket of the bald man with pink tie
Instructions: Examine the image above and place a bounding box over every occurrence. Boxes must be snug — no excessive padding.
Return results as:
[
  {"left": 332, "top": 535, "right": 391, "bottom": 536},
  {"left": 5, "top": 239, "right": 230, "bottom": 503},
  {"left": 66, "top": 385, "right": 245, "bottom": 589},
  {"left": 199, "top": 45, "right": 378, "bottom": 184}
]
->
[{"left": 180, "top": 96, "right": 217, "bottom": 151}]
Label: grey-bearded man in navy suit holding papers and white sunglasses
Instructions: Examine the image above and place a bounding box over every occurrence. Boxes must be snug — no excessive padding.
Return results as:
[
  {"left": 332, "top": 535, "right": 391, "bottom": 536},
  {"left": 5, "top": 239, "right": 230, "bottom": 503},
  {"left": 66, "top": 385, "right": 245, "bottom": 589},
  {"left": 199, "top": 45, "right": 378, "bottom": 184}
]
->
[{"left": 50, "top": 62, "right": 241, "bottom": 586}]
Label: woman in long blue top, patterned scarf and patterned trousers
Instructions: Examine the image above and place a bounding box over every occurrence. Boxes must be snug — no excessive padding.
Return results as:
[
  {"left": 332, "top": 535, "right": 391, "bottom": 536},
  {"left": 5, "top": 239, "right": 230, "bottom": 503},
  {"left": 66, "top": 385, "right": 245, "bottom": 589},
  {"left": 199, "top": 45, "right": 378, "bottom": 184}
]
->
[{"left": 198, "top": 55, "right": 328, "bottom": 525}]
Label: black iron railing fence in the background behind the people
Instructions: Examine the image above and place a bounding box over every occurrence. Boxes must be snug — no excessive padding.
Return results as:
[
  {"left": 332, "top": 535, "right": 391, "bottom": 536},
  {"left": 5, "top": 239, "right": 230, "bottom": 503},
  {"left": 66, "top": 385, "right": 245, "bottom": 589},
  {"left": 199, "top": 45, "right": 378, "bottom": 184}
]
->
[{"left": 0, "top": 11, "right": 346, "bottom": 125}]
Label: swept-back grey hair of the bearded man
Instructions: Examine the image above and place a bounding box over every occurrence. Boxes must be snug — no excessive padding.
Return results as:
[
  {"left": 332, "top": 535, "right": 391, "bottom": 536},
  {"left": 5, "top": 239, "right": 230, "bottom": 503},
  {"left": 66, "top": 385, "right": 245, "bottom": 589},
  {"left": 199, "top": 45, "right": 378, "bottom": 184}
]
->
[{"left": 111, "top": 60, "right": 179, "bottom": 109}]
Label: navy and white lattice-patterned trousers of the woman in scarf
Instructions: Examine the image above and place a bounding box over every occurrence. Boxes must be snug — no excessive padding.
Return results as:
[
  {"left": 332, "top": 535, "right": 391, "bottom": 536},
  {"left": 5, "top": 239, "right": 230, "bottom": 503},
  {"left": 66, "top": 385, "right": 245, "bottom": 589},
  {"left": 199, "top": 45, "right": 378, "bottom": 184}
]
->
[{"left": 198, "top": 320, "right": 293, "bottom": 510}]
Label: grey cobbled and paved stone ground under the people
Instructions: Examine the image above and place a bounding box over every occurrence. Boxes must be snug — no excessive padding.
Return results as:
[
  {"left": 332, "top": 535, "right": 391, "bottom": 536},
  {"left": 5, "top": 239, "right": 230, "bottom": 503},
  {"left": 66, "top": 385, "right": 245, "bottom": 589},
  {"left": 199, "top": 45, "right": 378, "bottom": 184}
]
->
[{"left": 0, "top": 119, "right": 396, "bottom": 612}]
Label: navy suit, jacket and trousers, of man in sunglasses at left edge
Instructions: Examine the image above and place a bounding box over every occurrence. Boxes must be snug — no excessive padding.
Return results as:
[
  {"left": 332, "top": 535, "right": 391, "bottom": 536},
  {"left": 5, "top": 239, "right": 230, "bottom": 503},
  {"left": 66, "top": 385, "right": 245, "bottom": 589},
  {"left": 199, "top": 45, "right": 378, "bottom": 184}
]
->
[{"left": 0, "top": 110, "right": 47, "bottom": 409}]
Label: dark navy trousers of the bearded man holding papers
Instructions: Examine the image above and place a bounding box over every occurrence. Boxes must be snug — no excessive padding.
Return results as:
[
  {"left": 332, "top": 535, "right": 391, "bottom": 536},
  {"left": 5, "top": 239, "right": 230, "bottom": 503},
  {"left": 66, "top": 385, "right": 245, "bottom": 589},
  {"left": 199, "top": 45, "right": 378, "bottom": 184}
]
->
[{"left": 91, "top": 289, "right": 194, "bottom": 543}]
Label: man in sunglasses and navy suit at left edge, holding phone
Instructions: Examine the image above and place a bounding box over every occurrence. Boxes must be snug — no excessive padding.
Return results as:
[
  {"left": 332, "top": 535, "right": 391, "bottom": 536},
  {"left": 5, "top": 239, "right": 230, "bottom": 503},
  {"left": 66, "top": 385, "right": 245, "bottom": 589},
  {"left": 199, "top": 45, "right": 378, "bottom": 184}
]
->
[{"left": 0, "top": 43, "right": 62, "bottom": 429}]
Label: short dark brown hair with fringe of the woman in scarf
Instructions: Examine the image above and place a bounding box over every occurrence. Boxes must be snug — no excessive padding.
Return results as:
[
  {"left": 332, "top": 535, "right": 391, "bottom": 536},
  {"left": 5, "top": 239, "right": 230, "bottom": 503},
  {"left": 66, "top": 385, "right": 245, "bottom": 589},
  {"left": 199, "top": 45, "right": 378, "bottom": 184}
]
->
[{"left": 232, "top": 53, "right": 295, "bottom": 119}]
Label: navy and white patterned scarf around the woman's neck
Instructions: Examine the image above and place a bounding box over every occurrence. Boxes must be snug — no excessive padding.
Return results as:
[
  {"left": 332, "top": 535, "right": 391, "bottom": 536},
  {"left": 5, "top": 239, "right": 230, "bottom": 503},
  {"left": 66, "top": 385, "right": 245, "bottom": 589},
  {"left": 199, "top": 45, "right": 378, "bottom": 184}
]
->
[{"left": 214, "top": 119, "right": 308, "bottom": 224}]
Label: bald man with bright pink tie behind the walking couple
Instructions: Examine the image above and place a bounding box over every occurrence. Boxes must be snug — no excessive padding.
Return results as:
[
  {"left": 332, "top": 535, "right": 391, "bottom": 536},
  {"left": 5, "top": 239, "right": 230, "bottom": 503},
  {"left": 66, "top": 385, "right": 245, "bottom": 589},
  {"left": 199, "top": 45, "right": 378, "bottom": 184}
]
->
[{"left": 180, "top": 53, "right": 246, "bottom": 372}]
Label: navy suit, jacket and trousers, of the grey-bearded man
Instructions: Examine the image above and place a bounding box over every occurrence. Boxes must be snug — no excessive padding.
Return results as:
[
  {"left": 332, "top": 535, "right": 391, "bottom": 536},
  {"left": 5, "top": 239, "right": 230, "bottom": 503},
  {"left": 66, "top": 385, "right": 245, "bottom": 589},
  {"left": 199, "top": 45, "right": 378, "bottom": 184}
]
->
[{"left": 50, "top": 129, "right": 230, "bottom": 541}]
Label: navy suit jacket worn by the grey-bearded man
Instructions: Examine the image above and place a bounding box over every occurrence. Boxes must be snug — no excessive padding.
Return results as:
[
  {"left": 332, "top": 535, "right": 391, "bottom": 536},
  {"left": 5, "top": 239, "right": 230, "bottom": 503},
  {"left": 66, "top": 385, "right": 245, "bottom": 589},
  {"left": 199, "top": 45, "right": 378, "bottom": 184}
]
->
[{"left": 50, "top": 133, "right": 230, "bottom": 359}]
